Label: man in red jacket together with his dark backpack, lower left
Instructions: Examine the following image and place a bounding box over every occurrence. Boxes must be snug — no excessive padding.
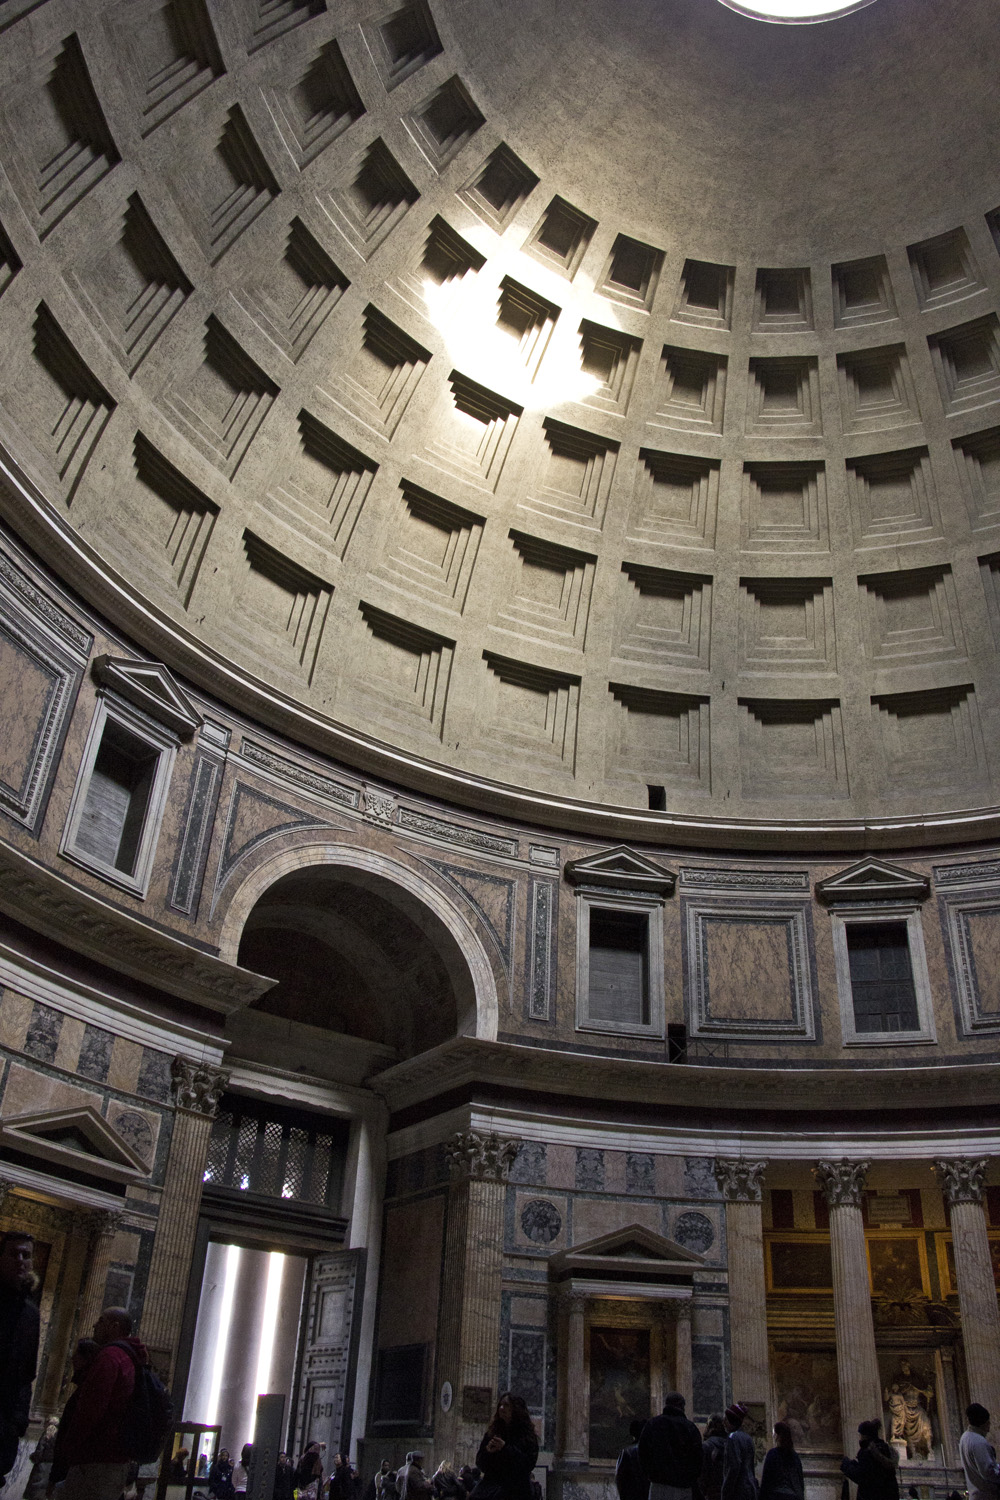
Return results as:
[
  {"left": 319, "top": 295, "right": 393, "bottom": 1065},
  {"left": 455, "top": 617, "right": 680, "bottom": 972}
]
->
[{"left": 55, "top": 1308, "right": 169, "bottom": 1500}]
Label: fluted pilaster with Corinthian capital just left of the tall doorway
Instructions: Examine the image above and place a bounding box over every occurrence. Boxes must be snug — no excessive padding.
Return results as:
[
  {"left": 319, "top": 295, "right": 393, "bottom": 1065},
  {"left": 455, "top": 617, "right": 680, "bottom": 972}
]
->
[{"left": 141, "top": 1058, "right": 229, "bottom": 1374}]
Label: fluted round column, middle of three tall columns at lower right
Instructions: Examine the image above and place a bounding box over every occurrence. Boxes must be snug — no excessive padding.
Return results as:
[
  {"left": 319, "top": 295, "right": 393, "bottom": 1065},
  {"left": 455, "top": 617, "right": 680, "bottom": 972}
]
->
[{"left": 813, "top": 1161, "right": 882, "bottom": 1454}]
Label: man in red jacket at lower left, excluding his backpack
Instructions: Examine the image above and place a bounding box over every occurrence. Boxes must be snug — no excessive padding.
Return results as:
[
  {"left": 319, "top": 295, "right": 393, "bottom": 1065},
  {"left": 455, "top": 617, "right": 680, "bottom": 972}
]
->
[{"left": 54, "top": 1308, "right": 150, "bottom": 1500}]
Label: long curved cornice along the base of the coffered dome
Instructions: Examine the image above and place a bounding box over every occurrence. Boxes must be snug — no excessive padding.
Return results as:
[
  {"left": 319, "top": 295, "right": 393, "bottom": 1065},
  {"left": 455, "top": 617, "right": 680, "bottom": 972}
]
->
[{"left": 0, "top": 446, "right": 1000, "bottom": 854}]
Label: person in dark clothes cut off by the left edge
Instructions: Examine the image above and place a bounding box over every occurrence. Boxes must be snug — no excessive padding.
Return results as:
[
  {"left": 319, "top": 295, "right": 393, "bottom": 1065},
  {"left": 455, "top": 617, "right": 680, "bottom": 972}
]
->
[{"left": 0, "top": 1230, "right": 39, "bottom": 1488}]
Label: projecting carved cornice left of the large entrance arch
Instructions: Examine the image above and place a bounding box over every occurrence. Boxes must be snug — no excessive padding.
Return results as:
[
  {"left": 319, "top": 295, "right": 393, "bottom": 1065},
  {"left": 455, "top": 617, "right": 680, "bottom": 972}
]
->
[{"left": 0, "top": 843, "right": 274, "bottom": 1016}]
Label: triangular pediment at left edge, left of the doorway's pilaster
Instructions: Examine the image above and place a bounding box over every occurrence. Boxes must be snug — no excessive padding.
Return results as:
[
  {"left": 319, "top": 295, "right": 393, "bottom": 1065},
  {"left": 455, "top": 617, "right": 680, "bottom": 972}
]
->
[{"left": 0, "top": 1106, "right": 148, "bottom": 1185}]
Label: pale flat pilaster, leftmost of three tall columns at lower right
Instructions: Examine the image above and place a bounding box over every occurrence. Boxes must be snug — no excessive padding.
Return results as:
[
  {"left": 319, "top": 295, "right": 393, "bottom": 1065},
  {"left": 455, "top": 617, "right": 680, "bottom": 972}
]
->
[{"left": 715, "top": 1157, "right": 771, "bottom": 1430}]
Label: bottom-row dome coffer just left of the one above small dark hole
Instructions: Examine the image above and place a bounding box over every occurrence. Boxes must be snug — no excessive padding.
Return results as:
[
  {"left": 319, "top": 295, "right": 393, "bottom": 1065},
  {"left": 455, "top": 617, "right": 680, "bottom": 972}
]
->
[{"left": 478, "top": 651, "right": 580, "bottom": 773}]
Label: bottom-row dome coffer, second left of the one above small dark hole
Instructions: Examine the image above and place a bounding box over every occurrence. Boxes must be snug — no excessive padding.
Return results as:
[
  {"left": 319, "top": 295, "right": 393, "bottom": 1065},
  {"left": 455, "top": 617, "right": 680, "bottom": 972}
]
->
[{"left": 355, "top": 600, "right": 454, "bottom": 740}]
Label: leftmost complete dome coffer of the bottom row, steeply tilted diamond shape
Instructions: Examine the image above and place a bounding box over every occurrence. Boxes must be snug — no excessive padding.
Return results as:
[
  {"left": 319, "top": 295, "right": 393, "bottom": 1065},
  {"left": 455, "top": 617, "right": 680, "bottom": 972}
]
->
[{"left": 3, "top": 302, "right": 115, "bottom": 500}]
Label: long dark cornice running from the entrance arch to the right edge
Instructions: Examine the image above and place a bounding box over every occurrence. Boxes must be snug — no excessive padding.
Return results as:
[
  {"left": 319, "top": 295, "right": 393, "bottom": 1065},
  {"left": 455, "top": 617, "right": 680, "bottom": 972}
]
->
[{"left": 367, "top": 1037, "right": 1000, "bottom": 1116}]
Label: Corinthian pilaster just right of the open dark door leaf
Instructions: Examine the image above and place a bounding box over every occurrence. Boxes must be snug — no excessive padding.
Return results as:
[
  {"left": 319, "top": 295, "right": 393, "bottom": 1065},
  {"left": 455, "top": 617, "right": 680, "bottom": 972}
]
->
[{"left": 435, "top": 1131, "right": 519, "bottom": 1469}]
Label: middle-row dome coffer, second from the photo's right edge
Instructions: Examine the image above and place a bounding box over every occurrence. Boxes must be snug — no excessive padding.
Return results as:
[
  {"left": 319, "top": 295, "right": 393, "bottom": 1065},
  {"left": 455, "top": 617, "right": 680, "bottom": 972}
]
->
[{"left": 847, "top": 447, "right": 942, "bottom": 548}]
